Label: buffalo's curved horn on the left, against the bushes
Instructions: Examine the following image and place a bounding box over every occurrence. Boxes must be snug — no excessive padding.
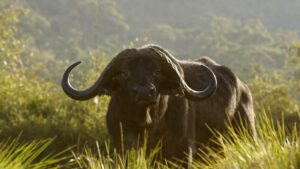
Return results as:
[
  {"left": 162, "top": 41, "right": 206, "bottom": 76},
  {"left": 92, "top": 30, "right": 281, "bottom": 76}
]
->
[{"left": 61, "top": 49, "right": 134, "bottom": 100}]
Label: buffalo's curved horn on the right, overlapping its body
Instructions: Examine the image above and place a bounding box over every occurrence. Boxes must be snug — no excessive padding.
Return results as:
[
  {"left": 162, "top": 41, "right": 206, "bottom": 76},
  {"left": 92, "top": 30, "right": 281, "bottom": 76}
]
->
[{"left": 147, "top": 45, "right": 218, "bottom": 101}]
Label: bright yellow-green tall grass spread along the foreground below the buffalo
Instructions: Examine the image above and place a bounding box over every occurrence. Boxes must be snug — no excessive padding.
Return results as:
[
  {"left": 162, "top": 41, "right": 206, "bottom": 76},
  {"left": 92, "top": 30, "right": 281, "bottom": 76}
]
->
[{"left": 0, "top": 111, "right": 300, "bottom": 169}]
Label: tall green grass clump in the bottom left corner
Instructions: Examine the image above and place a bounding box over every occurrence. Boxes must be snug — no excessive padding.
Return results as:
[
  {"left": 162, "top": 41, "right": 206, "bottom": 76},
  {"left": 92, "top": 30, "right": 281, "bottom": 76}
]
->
[{"left": 0, "top": 139, "right": 68, "bottom": 169}]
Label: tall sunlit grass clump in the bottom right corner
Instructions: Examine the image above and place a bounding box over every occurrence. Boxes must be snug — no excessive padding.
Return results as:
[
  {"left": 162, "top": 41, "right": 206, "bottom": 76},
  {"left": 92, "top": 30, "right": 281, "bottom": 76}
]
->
[{"left": 193, "top": 111, "right": 300, "bottom": 169}]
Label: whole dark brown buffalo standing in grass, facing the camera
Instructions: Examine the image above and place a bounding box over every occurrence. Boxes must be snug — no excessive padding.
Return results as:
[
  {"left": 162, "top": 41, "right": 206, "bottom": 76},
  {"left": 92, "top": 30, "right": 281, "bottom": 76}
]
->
[{"left": 62, "top": 45, "right": 255, "bottom": 162}]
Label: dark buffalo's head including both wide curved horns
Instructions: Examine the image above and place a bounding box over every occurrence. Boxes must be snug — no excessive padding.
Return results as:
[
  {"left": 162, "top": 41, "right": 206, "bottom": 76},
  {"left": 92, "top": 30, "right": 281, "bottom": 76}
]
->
[{"left": 62, "top": 45, "right": 217, "bottom": 105}]
